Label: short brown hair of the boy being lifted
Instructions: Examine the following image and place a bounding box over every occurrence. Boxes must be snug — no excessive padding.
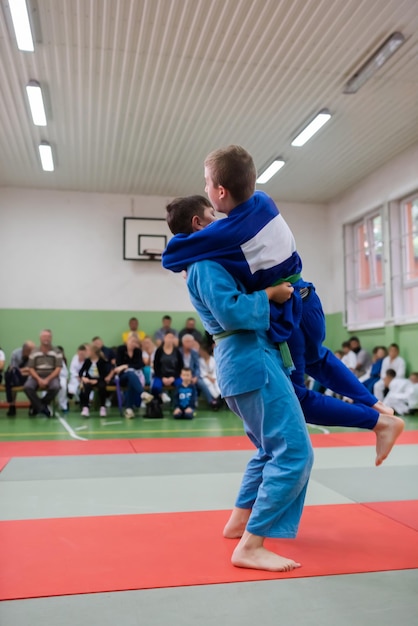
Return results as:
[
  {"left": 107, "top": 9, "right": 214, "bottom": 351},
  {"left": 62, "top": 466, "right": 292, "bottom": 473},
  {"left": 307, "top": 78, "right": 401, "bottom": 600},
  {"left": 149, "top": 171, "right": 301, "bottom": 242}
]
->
[{"left": 205, "top": 145, "right": 257, "bottom": 203}]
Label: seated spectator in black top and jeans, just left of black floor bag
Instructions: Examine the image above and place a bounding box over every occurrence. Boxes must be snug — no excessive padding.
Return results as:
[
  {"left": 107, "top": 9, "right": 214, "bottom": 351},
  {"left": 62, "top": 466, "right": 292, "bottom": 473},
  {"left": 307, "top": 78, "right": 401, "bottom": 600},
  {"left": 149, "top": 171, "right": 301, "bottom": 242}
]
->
[{"left": 113, "top": 332, "right": 145, "bottom": 419}]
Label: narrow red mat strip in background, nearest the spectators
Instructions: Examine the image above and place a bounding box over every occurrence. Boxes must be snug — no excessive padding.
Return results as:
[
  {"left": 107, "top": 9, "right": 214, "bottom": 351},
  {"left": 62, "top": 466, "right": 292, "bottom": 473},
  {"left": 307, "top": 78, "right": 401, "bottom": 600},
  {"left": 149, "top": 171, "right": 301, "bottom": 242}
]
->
[{"left": 0, "top": 430, "right": 418, "bottom": 457}]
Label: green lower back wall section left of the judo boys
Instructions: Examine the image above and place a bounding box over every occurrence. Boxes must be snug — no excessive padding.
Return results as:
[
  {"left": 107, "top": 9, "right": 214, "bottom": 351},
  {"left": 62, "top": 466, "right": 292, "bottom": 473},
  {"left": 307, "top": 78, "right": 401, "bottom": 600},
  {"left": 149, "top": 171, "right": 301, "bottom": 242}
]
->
[{"left": 0, "top": 309, "right": 202, "bottom": 359}]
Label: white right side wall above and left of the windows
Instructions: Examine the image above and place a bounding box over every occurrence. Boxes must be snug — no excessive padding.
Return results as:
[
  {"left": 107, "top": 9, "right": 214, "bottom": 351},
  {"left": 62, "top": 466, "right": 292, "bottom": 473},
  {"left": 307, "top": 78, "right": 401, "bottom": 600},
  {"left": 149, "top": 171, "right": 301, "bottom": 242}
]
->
[{"left": 324, "top": 144, "right": 418, "bottom": 313}]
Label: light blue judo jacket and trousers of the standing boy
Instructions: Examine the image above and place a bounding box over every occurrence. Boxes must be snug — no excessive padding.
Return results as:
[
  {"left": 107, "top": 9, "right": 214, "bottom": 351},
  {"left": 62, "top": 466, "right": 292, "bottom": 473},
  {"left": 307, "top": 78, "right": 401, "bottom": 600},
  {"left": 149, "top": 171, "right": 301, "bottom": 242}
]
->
[{"left": 187, "top": 261, "right": 313, "bottom": 538}]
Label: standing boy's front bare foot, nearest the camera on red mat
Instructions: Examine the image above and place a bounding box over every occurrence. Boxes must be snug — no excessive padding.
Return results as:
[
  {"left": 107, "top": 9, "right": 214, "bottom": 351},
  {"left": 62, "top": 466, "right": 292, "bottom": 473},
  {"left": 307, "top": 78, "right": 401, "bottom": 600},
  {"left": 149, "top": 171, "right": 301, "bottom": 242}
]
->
[{"left": 231, "top": 531, "right": 300, "bottom": 572}]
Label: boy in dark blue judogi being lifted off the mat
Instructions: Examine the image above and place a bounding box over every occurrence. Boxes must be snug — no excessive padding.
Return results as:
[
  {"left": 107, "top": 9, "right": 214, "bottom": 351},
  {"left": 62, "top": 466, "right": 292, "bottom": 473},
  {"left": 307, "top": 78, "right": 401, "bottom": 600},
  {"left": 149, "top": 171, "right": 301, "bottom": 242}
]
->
[{"left": 163, "top": 146, "right": 403, "bottom": 465}]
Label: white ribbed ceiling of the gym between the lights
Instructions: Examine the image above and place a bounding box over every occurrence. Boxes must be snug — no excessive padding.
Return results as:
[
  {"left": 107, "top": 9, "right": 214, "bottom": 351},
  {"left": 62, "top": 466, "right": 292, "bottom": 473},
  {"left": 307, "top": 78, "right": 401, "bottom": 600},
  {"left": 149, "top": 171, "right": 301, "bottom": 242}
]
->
[{"left": 0, "top": 0, "right": 418, "bottom": 202}]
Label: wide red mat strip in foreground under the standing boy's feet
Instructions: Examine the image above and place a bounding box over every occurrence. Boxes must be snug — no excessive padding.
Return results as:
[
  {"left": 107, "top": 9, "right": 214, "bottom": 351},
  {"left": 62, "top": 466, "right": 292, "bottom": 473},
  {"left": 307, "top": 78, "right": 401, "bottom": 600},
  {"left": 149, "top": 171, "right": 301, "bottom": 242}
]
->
[{"left": 0, "top": 502, "right": 418, "bottom": 599}]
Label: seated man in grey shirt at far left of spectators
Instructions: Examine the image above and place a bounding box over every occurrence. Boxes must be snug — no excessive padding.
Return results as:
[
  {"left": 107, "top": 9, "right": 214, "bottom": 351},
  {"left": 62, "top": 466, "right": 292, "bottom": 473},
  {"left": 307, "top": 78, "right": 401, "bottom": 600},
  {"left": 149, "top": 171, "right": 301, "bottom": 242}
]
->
[{"left": 24, "top": 330, "right": 62, "bottom": 417}]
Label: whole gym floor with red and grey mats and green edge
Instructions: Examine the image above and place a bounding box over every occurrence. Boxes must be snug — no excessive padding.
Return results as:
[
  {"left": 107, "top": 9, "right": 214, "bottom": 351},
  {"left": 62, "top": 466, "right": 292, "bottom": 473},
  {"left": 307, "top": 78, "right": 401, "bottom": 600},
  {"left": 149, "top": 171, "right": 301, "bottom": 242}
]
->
[{"left": 0, "top": 408, "right": 418, "bottom": 626}]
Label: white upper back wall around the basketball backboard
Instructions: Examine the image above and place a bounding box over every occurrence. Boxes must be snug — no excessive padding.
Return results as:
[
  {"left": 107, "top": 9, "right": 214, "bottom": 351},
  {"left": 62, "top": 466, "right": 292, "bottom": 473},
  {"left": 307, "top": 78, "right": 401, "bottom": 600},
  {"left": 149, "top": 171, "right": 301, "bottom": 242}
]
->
[{"left": 0, "top": 188, "right": 329, "bottom": 312}]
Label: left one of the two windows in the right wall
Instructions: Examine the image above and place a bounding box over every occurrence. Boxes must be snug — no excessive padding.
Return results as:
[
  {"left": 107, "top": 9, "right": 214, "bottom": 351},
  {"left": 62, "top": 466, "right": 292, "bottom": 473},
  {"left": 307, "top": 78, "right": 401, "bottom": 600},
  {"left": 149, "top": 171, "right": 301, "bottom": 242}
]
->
[{"left": 344, "top": 208, "right": 385, "bottom": 330}]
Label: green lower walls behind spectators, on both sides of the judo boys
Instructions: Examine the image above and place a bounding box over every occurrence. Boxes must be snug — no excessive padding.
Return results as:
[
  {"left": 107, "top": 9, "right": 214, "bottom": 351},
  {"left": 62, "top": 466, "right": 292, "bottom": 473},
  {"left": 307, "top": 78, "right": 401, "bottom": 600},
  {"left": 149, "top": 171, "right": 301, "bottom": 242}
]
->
[{"left": 0, "top": 309, "right": 418, "bottom": 372}]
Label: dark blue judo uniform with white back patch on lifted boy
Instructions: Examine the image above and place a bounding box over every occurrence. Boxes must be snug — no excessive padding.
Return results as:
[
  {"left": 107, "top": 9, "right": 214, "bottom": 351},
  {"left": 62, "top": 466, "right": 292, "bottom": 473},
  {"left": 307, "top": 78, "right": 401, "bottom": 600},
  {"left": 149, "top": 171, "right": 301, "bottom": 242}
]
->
[{"left": 163, "top": 191, "right": 379, "bottom": 429}]
